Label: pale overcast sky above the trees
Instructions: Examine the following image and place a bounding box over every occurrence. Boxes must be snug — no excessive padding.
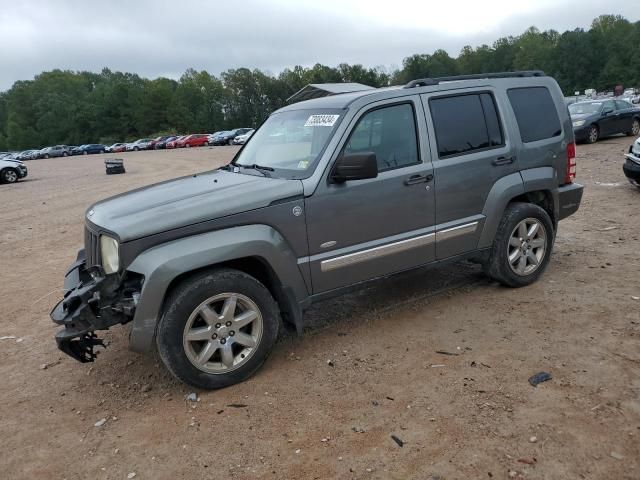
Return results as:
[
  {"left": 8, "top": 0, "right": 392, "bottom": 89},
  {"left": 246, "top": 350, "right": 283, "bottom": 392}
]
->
[{"left": 0, "top": 0, "right": 640, "bottom": 91}]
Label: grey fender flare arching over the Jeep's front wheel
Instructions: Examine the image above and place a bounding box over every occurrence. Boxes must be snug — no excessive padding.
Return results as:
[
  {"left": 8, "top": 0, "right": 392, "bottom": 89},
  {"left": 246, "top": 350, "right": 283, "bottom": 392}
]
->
[{"left": 127, "top": 225, "right": 309, "bottom": 352}]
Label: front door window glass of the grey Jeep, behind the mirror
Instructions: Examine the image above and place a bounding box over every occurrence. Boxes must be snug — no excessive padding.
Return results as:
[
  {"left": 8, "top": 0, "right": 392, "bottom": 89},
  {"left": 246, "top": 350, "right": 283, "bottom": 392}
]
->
[{"left": 343, "top": 103, "right": 420, "bottom": 172}]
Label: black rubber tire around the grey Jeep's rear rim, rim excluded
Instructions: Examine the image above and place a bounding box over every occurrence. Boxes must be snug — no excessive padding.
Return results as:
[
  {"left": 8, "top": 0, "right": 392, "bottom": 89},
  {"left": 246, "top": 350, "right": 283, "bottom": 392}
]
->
[{"left": 483, "top": 203, "right": 555, "bottom": 288}]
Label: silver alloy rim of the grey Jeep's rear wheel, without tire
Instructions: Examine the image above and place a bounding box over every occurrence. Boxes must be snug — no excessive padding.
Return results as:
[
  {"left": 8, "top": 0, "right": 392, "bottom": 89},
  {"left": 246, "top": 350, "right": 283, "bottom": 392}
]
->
[{"left": 508, "top": 218, "right": 547, "bottom": 276}]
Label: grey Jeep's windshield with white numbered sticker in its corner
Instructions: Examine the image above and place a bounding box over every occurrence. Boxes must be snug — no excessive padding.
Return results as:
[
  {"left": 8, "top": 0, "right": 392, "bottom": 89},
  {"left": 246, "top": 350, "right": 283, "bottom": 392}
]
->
[{"left": 233, "top": 109, "right": 343, "bottom": 178}]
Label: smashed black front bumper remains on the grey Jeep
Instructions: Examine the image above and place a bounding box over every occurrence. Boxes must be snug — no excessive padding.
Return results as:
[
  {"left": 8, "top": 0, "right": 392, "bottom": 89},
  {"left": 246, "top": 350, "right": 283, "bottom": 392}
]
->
[{"left": 50, "top": 250, "right": 139, "bottom": 363}]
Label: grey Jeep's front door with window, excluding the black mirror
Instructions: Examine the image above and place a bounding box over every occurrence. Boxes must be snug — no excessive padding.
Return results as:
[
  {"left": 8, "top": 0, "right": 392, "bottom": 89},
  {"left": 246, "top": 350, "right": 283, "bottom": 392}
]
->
[{"left": 305, "top": 97, "right": 435, "bottom": 293}]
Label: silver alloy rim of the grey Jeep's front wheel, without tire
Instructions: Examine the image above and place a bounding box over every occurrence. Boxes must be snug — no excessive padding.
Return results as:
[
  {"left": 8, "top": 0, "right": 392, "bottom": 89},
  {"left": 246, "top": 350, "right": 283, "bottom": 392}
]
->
[{"left": 182, "top": 293, "right": 263, "bottom": 374}]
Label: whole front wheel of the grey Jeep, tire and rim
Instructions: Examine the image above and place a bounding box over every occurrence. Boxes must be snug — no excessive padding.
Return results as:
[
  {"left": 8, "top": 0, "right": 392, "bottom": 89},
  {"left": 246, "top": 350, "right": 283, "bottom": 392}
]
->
[{"left": 156, "top": 269, "right": 280, "bottom": 389}]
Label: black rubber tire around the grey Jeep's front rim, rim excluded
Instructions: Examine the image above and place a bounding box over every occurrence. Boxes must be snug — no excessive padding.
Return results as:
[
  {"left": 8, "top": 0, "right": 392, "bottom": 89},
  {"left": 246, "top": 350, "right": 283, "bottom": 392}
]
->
[{"left": 156, "top": 269, "right": 281, "bottom": 390}]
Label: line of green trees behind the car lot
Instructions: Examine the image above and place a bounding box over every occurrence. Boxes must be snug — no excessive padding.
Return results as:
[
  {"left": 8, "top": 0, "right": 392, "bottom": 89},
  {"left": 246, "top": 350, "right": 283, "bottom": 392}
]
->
[{"left": 0, "top": 15, "right": 640, "bottom": 151}]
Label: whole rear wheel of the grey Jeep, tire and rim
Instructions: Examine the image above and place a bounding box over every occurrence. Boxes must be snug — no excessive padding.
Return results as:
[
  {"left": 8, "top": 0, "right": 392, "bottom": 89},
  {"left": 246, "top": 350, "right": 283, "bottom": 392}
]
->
[{"left": 484, "top": 203, "right": 554, "bottom": 288}]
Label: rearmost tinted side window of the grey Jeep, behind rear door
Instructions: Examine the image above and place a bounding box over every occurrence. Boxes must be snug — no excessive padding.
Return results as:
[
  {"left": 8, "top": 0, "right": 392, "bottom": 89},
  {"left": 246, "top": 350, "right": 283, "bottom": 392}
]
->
[{"left": 507, "top": 87, "right": 562, "bottom": 143}]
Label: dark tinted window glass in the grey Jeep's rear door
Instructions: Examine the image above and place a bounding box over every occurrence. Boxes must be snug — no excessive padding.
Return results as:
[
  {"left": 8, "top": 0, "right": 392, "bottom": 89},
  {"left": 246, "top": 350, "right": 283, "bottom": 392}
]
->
[{"left": 429, "top": 93, "right": 504, "bottom": 158}]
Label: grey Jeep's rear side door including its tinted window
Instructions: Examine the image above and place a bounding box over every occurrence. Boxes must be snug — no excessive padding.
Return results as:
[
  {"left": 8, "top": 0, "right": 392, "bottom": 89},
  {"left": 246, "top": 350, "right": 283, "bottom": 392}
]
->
[{"left": 422, "top": 89, "right": 518, "bottom": 259}]
